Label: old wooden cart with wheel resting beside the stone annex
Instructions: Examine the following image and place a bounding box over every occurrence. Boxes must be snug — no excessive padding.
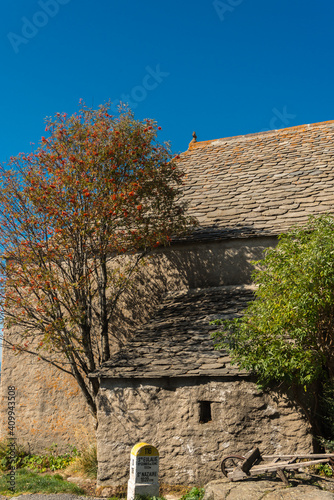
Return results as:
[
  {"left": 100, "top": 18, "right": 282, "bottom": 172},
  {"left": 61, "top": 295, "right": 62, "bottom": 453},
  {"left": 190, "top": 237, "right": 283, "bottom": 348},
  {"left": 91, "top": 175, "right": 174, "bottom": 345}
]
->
[{"left": 221, "top": 448, "right": 334, "bottom": 484}]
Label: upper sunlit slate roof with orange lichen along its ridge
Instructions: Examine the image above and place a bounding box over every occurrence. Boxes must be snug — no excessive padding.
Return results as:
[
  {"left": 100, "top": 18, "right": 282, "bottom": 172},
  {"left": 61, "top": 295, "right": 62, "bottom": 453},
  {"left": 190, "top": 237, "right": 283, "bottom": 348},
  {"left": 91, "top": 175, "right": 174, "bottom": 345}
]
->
[{"left": 179, "top": 121, "right": 334, "bottom": 239}]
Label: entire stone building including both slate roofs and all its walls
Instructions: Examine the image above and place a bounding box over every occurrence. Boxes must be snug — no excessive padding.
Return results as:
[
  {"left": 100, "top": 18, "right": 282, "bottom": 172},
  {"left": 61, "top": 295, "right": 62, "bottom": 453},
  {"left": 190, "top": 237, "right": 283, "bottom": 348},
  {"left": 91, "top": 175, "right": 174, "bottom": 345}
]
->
[{"left": 2, "top": 122, "right": 334, "bottom": 488}]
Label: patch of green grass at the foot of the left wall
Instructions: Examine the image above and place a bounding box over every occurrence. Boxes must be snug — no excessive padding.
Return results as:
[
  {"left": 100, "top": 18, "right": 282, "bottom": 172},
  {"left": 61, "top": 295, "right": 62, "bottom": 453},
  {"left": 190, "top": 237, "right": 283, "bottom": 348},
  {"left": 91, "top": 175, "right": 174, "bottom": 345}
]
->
[{"left": 0, "top": 469, "right": 85, "bottom": 495}]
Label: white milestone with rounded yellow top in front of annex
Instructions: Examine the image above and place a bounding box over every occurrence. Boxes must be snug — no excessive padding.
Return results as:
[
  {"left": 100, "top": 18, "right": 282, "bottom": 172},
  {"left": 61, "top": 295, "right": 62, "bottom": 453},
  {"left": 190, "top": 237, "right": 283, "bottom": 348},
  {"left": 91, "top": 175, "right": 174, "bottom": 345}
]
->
[{"left": 127, "top": 443, "right": 159, "bottom": 500}]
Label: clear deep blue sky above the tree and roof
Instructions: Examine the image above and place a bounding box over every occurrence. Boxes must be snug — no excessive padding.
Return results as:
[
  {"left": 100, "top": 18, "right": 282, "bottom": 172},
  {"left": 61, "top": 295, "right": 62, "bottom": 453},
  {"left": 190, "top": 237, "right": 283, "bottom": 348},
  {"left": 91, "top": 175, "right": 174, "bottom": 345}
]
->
[{"left": 0, "top": 0, "right": 334, "bottom": 161}]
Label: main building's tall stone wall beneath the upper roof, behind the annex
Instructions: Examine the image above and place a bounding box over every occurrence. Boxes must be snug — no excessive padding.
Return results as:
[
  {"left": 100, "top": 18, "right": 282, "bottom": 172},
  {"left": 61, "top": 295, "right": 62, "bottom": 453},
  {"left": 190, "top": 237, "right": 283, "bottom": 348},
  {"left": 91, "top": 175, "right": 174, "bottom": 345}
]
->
[{"left": 0, "top": 237, "right": 276, "bottom": 453}]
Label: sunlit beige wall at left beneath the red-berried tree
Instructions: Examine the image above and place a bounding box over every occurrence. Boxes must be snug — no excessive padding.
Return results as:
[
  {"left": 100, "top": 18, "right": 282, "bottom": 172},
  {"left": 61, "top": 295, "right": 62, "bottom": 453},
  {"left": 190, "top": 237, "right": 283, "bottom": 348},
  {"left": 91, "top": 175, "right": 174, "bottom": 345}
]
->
[{"left": 1, "top": 332, "right": 95, "bottom": 453}]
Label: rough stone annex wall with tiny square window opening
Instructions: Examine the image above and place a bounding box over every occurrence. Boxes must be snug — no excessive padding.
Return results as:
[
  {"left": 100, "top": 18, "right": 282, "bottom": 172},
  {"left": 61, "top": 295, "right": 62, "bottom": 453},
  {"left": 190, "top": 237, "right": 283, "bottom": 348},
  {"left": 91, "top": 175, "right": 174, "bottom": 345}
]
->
[{"left": 98, "top": 377, "right": 312, "bottom": 489}]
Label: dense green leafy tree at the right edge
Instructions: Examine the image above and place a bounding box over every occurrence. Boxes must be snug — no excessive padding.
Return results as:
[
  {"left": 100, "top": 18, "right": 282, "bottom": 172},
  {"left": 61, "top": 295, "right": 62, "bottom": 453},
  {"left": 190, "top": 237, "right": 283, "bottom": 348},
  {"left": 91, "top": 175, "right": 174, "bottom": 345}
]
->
[{"left": 215, "top": 214, "right": 334, "bottom": 446}]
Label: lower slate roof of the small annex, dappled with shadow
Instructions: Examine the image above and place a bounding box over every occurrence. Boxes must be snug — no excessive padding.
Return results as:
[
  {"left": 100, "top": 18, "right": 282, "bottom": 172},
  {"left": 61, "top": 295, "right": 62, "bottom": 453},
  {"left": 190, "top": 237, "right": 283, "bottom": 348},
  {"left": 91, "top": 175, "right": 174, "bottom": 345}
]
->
[{"left": 92, "top": 285, "right": 254, "bottom": 378}]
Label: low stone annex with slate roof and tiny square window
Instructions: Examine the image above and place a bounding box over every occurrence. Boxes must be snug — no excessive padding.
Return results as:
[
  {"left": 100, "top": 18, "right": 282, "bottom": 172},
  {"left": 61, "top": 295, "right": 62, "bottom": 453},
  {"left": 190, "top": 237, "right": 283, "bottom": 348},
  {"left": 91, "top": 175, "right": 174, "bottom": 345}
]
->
[{"left": 93, "top": 285, "right": 312, "bottom": 494}]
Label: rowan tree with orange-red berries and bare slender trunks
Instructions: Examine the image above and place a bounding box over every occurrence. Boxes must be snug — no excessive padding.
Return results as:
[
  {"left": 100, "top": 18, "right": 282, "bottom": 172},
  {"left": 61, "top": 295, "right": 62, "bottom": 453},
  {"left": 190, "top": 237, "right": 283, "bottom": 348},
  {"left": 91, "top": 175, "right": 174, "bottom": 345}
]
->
[{"left": 0, "top": 105, "right": 194, "bottom": 416}]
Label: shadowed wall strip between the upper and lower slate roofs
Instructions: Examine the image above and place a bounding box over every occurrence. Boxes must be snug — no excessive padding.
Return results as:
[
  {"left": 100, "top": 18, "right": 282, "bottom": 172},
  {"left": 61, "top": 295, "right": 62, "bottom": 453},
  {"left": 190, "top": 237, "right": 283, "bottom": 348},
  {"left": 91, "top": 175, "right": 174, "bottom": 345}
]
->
[{"left": 112, "top": 236, "right": 277, "bottom": 352}]
